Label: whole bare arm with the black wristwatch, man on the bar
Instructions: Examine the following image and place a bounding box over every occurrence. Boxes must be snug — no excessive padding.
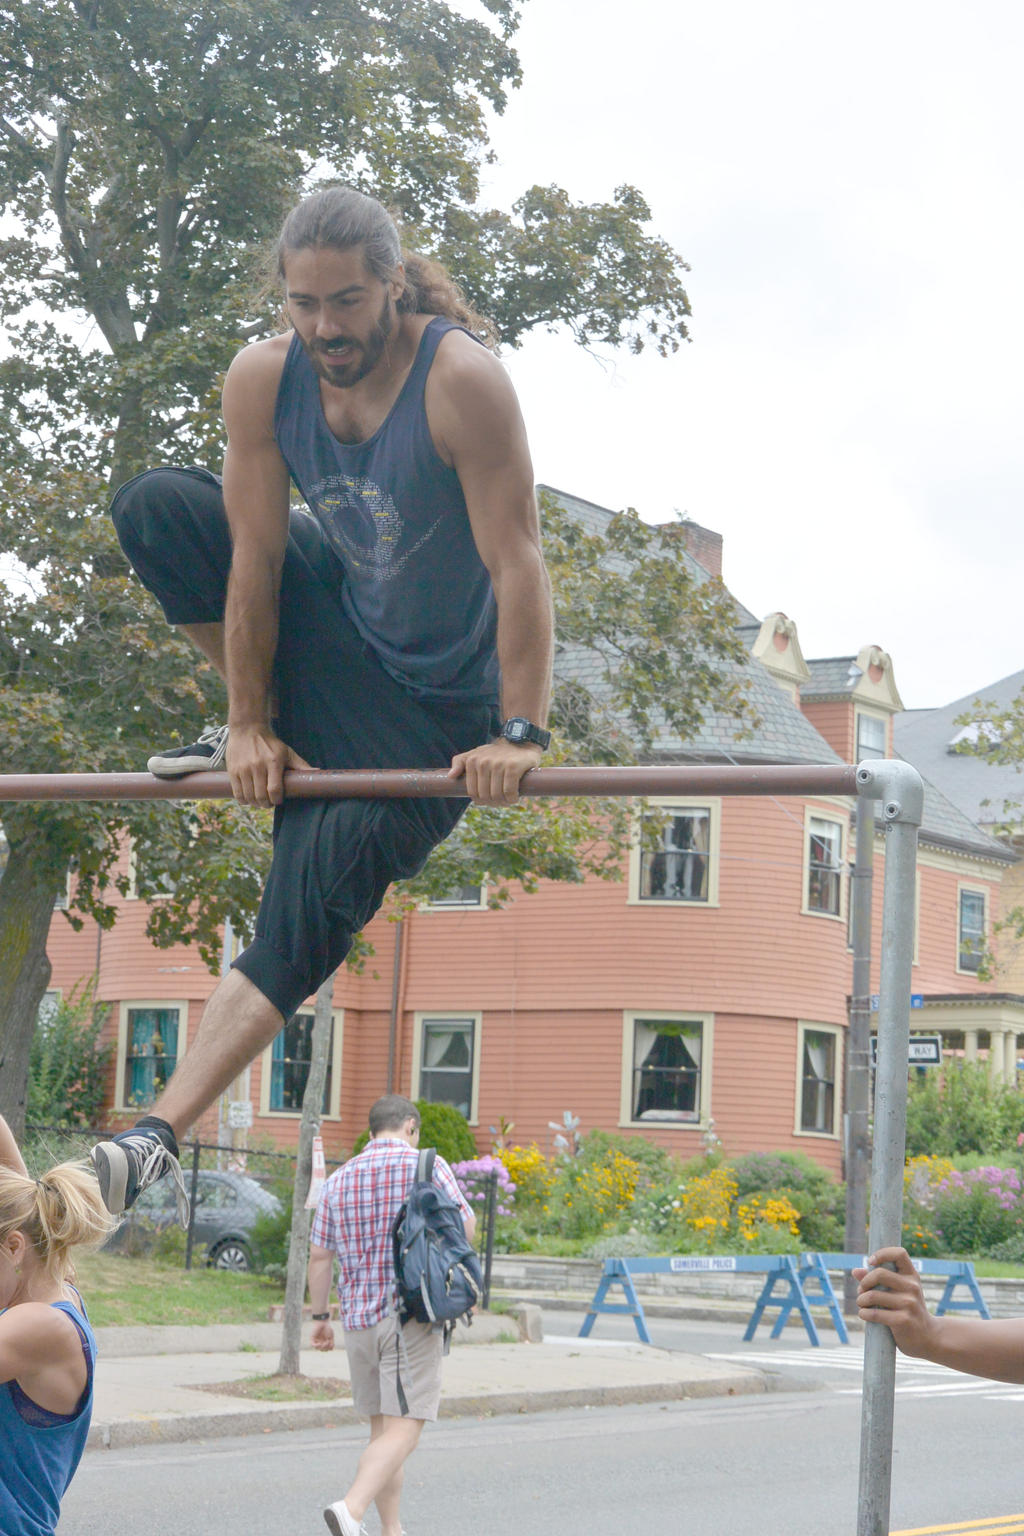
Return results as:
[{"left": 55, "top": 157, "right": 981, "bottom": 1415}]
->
[{"left": 427, "top": 332, "right": 554, "bottom": 805}]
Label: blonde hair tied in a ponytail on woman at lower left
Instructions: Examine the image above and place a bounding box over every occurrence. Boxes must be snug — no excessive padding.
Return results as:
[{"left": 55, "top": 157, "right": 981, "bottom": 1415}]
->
[{"left": 0, "top": 1163, "right": 117, "bottom": 1284}]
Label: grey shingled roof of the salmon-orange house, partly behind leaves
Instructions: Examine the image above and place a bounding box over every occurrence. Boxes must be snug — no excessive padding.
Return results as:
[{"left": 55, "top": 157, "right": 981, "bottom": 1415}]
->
[{"left": 539, "top": 485, "right": 1024, "bottom": 863}]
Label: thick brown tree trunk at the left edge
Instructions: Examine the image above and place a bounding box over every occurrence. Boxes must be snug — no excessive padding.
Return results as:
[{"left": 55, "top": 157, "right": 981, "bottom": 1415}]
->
[{"left": 0, "top": 843, "right": 55, "bottom": 1140}]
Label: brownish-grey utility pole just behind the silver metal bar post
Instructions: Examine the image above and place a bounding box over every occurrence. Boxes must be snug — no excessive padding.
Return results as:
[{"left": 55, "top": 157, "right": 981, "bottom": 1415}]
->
[{"left": 843, "top": 796, "right": 875, "bottom": 1316}]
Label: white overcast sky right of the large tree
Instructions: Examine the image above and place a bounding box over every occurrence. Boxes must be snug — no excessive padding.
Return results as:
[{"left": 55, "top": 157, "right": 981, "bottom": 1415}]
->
[{"left": 485, "top": 0, "right": 1024, "bottom": 708}]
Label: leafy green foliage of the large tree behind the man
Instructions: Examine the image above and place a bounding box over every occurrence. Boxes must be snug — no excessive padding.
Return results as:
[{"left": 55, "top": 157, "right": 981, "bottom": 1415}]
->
[{"left": 0, "top": 0, "right": 729, "bottom": 1129}]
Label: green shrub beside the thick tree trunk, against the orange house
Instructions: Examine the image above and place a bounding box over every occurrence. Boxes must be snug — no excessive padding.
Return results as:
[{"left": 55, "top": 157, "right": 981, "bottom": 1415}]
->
[{"left": 28, "top": 982, "right": 114, "bottom": 1127}]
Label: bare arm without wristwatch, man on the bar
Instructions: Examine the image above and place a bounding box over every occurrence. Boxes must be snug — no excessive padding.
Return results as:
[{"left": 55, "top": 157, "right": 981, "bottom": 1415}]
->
[{"left": 224, "top": 343, "right": 309, "bottom": 806}]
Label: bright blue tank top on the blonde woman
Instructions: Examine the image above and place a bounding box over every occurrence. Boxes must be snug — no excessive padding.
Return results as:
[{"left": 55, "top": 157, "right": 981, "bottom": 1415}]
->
[{"left": 0, "top": 1301, "right": 97, "bottom": 1536}]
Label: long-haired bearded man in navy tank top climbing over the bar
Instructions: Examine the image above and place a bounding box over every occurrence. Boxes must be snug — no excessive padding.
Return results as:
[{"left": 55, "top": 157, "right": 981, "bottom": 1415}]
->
[{"left": 92, "top": 186, "right": 553, "bottom": 1220}]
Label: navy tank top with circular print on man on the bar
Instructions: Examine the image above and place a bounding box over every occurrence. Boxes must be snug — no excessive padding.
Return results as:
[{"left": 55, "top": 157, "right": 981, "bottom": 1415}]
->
[{"left": 273, "top": 316, "right": 497, "bottom": 699}]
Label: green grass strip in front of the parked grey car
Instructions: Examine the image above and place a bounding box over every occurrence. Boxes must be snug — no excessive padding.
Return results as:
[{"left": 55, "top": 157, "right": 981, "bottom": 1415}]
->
[{"left": 77, "top": 1253, "right": 282, "bottom": 1329}]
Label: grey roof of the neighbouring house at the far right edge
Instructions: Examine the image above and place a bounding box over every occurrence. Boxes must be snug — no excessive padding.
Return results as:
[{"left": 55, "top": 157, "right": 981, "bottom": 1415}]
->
[{"left": 895, "top": 671, "right": 1024, "bottom": 826}]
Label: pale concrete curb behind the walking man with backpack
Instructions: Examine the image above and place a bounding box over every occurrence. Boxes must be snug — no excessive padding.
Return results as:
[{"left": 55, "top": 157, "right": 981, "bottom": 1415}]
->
[{"left": 86, "top": 1370, "right": 773, "bottom": 1450}]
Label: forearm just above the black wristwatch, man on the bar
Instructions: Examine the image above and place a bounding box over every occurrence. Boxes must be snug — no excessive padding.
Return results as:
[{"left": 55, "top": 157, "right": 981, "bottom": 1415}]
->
[{"left": 491, "top": 545, "right": 554, "bottom": 725}]
